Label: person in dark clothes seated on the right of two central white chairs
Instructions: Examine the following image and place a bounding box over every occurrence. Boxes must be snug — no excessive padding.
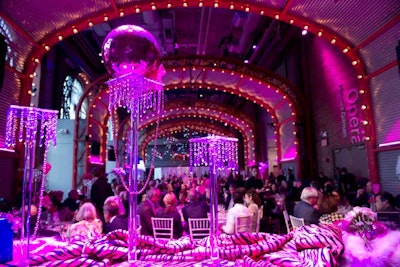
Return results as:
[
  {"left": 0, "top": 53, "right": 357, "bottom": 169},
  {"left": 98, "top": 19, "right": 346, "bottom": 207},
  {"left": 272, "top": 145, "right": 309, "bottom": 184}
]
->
[{"left": 182, "top": 189, "right": 210, "bottom": 223}]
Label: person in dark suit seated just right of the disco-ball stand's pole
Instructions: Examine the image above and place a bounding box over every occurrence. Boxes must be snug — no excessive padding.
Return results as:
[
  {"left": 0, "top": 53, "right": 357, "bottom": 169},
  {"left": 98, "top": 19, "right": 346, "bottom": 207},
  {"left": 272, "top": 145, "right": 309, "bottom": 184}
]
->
[{"left": 138, "top": 188, "right": 161, "bottom": 236}]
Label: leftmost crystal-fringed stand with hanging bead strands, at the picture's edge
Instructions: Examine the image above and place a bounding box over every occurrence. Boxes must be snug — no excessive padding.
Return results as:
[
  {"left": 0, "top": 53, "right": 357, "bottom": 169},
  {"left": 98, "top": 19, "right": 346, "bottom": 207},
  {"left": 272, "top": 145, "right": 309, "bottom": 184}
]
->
[{"left": 5, "top": 105, "right": 58, "bottom": 266}]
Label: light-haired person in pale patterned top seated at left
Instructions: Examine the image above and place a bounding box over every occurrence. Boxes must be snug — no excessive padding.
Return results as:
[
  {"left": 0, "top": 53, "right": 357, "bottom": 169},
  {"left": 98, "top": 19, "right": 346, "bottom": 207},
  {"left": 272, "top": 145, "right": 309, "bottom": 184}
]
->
[{"left": 67, "top": 202, "right": 103, "bottom": 240}]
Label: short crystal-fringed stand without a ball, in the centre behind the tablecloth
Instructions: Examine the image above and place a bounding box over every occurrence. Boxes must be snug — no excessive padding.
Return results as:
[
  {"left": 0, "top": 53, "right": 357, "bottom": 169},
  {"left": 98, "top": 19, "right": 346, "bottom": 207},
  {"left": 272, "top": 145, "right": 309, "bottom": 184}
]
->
[{"left": 189, "top": 135, "right": 238, "bottom": 266}]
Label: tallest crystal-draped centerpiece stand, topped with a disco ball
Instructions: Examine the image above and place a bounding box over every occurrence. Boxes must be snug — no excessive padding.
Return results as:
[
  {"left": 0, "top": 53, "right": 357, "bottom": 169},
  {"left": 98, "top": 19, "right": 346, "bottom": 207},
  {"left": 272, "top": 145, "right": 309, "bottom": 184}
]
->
[{"left": 102, "top": 25, "right": 165, "bottom": 266}]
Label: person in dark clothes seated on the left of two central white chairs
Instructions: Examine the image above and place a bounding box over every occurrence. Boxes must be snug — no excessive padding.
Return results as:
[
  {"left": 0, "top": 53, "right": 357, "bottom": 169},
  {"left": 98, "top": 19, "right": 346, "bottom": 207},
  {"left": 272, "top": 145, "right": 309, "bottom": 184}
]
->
[{"left": 155, "top": 192, "right": 183, "bottom": 239}]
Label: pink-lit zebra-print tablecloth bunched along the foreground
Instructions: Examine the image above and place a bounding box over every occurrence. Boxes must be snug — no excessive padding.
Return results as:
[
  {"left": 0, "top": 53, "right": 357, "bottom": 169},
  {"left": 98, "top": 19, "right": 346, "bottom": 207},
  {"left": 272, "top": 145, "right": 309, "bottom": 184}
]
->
[{"left": 25, "top": 225, "right": 344, "bottom": 267}]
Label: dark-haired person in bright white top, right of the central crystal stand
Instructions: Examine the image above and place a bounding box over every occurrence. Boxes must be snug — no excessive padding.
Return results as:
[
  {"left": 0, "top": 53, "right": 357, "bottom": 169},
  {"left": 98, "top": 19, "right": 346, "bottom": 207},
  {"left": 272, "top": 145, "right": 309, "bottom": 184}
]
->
[{"left": 222, "top": 190, "right": 250, "bottom": 234}]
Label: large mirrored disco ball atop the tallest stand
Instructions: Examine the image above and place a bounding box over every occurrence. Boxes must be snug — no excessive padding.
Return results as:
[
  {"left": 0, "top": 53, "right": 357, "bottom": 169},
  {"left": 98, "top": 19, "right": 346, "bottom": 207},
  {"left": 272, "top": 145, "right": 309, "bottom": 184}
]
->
[{"left": 102, "top": 25, "right": 161, "bottom": 80}]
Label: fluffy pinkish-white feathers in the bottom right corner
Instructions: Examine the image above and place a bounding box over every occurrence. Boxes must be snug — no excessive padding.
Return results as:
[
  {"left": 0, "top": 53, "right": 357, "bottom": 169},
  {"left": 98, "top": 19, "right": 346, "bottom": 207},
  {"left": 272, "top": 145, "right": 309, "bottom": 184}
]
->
[{"left": 341, "top": 231, "right": 400, "bottom": 267}]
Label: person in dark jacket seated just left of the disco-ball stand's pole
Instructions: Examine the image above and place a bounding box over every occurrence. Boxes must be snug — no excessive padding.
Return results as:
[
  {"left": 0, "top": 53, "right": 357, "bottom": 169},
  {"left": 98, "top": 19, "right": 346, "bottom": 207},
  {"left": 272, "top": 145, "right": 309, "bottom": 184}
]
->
[{"left": 103, "top": 196, "right": 128, "bottom": 234}]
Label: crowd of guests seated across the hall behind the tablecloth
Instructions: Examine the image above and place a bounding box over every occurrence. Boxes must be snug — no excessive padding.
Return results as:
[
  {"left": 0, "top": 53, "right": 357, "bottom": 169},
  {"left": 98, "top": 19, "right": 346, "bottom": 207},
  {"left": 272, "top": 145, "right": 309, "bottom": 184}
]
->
[{"left": 7, "top": 164, "right": 399, "bottom": 242}]
